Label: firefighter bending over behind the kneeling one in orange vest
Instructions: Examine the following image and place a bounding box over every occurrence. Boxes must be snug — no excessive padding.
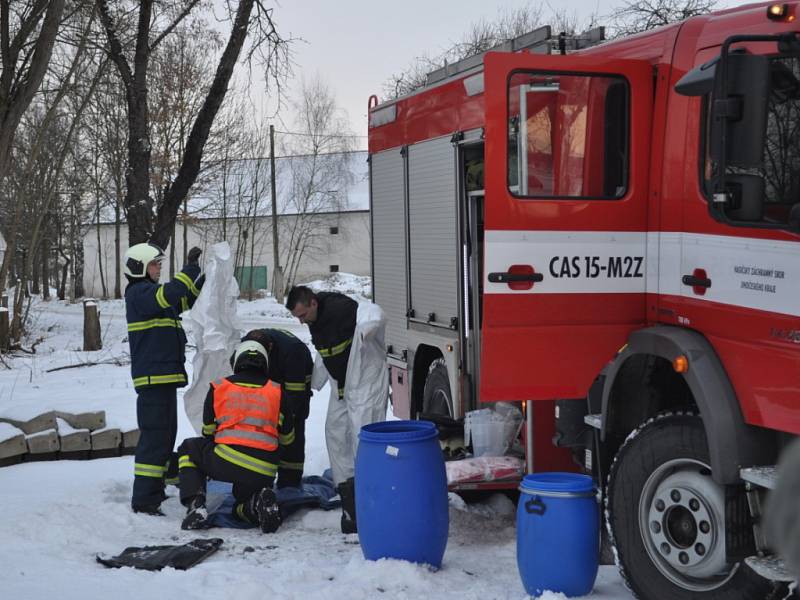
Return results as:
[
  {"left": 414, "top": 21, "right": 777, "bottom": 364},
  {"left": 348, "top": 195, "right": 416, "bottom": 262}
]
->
[{"left": 242, "top": 329, "right": 314, "bottom": 488}]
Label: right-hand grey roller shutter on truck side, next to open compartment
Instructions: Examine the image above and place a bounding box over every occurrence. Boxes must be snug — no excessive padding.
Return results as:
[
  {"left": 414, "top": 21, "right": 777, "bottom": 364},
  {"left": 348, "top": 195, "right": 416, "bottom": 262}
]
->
[{"left": 408, "top": 137, "right": 458, "bottom": 325}]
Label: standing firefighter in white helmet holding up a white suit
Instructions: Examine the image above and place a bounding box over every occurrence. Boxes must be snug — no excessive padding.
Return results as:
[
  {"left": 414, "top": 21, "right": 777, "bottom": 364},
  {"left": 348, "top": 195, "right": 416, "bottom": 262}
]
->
[{"left": 123, "top": 243, "right": 204, "bottom": 515}]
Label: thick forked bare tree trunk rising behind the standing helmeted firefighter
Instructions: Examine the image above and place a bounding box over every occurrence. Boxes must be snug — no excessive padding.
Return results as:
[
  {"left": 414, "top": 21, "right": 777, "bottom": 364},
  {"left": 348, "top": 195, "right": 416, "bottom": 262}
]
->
[{"left": 96, "top": 0, "right": 289, "bottom": 246}]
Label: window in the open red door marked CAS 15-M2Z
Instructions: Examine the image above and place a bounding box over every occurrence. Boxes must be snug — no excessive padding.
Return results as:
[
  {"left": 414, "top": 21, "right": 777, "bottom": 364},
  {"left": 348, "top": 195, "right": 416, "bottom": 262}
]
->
[{"left": 508, "top": 72, "right": 629, "bottom": 199}]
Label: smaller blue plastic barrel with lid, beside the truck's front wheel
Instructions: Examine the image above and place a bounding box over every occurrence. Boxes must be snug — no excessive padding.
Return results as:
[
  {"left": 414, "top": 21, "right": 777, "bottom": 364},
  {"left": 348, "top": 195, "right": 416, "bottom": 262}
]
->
[{"left": 517, "top": 473, "right": 600, "bottom": 596}]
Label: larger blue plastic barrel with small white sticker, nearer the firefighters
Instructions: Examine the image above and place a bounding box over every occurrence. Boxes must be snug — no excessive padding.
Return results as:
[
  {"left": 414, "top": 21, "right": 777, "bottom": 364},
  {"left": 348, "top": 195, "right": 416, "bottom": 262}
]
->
[{"left": 355, "top": 421, "right": 450, "bottom": 568}]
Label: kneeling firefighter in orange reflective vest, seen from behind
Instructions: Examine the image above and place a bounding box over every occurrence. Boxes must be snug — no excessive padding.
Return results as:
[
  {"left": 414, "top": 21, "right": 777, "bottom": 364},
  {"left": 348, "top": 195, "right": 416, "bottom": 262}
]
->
[{"left": 178, "top": 340, "right": 294, "bottom": 533}]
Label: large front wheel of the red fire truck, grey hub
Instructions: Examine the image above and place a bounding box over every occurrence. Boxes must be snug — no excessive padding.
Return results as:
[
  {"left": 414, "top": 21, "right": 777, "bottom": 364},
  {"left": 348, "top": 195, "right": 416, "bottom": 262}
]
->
[{"left": 606, "top": 414, "right": 779, "bottom": 600}]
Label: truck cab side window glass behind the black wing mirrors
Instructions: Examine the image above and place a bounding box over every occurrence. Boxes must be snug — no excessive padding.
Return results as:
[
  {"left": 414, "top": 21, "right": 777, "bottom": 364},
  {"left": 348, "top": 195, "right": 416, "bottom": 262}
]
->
[{"left": 703, "top": 56, "right": 800, "bottom": 225}]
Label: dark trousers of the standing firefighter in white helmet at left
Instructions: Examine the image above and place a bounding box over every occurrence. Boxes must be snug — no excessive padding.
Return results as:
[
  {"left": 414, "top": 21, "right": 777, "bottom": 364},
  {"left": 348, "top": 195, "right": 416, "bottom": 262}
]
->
[{"left": 131, "top": 385, "right": 178, "bottom": 507}]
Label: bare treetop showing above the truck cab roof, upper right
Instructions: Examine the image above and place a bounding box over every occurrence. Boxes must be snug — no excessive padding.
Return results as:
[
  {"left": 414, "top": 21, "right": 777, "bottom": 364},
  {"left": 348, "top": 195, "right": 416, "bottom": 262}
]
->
[{"left": 608, "top": 0, "right": 718, "bottom": 37}]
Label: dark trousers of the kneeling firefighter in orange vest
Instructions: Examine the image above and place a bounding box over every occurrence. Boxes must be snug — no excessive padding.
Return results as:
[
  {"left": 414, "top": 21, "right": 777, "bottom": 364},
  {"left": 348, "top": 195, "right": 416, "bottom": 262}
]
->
[{"left": 178, "top": 437, "right": 275, "bottom": 523}]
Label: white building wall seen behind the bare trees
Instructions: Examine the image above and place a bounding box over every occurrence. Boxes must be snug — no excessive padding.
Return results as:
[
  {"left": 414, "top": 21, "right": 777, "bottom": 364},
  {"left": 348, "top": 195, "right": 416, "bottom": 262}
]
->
[{"left": 83, "top": 211, "right": 370, "bottom": 297}]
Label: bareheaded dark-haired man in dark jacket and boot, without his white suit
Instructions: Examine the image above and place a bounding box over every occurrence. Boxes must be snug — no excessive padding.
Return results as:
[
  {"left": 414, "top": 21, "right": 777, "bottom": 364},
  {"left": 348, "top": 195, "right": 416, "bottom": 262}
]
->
[{"left": 286, "top": 286, "right": 358, "bottom": 533}]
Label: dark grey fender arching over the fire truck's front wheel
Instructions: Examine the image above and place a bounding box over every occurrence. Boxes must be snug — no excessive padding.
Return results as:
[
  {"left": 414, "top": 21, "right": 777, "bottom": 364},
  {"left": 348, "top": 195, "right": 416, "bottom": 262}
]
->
[{"left": 601, "top": 325, "right": 776, "bottom": 484}]
